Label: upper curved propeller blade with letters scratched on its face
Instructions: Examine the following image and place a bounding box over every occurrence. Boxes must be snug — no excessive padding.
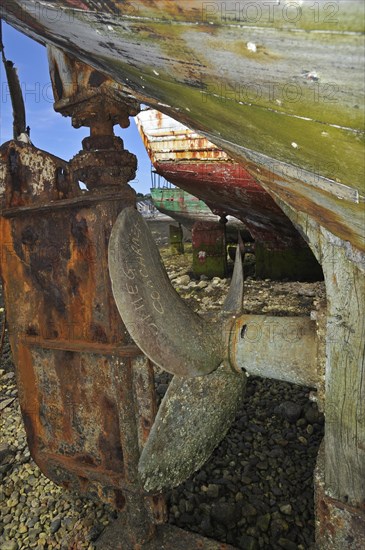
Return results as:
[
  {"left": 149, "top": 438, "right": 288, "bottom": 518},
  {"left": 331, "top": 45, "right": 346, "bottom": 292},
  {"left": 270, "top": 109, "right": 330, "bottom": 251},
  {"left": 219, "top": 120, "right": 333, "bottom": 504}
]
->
[{"left": 109, "top": 208, "right": 224, "bottom": 377}]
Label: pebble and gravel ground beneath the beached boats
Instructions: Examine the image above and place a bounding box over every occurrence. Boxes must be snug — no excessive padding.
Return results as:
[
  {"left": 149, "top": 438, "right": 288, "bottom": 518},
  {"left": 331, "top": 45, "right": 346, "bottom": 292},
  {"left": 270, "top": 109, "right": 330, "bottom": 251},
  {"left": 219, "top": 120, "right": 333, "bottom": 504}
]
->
[{"left": 0, "top": 244, "right": 325, "bottom": 550}]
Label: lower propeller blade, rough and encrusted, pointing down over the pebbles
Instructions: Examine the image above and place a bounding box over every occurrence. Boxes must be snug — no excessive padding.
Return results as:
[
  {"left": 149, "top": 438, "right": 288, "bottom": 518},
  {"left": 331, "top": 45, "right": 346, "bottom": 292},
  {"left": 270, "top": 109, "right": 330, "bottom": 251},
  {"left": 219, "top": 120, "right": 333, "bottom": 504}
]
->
[{"left": 138, "top": 365, "right": 246, "bottom": 491}]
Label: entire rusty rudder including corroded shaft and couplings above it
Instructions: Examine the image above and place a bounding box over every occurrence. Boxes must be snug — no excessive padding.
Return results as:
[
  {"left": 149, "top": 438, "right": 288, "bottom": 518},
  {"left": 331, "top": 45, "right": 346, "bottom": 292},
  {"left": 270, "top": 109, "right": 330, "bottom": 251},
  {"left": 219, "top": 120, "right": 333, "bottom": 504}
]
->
[{"left": 0, "top": 50, "right": 169, "bottom": 548}]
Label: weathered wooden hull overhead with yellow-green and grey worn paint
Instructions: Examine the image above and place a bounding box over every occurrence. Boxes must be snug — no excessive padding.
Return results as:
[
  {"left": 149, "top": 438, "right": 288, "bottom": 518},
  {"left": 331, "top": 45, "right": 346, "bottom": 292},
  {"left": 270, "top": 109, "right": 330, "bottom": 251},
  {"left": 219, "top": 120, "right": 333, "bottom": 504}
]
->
[{"left": 2, "top": 0, "right": 365, "bottom": 251}]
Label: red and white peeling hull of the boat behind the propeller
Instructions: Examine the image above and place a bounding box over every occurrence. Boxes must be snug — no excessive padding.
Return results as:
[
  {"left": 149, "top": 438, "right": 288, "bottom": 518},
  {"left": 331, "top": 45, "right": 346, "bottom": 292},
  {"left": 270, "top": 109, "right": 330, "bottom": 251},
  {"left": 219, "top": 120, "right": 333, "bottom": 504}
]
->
[{"left": 136, "top": 110, "right": 306, "bottom": 250}]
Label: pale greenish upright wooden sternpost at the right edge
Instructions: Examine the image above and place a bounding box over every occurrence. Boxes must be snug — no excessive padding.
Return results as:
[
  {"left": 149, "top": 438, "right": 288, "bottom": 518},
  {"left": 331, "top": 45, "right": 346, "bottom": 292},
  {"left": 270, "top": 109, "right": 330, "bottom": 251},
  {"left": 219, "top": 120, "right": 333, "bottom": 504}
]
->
[{"left": 268, "top": 197, "right": 365, "bottom": 507}]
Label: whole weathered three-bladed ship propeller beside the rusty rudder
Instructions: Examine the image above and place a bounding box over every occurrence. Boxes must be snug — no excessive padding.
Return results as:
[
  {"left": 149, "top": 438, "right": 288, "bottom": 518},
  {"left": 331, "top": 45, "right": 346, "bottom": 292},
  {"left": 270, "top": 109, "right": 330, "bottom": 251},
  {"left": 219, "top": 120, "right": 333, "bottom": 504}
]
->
[{"left": 109, "top": 208, "right": 246, "bottom": 491}]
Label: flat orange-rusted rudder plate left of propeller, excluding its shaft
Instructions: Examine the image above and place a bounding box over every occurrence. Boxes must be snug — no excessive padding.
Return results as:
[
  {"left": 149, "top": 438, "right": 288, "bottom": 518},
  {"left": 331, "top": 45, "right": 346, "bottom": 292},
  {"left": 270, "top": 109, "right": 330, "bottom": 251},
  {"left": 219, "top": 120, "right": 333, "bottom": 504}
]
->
[{"left": 0, "top": 140, "right": 161, "bottom": 515}]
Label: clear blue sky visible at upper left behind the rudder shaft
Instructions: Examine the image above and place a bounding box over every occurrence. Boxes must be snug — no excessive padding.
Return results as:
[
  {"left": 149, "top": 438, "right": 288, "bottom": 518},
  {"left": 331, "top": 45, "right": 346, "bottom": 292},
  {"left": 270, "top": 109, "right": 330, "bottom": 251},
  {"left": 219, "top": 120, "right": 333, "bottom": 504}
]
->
[{"left": 0, "top": 22, "right": 151, "bottom": 197}]
